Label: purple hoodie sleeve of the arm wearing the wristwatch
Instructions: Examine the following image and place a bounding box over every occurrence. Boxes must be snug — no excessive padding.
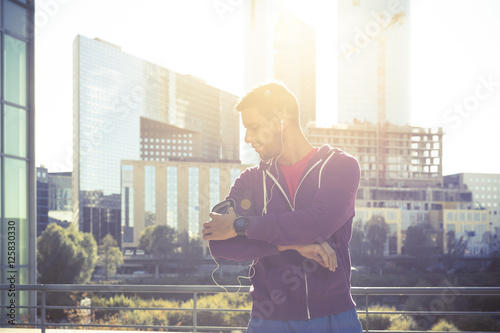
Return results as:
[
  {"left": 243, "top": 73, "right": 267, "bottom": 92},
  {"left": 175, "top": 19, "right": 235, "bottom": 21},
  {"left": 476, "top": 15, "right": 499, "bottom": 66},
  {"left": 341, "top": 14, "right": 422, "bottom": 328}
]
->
[{"left": 247, "top": 154, "right": 360, "bottom": 246}]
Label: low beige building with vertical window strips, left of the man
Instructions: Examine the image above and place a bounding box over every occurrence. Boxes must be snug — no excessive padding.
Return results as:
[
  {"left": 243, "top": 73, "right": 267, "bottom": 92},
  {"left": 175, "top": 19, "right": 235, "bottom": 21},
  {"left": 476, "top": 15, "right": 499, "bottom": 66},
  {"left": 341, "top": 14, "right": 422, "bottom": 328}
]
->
[{"left": 121, "top": 160, "right": 248, "bottom": 247}]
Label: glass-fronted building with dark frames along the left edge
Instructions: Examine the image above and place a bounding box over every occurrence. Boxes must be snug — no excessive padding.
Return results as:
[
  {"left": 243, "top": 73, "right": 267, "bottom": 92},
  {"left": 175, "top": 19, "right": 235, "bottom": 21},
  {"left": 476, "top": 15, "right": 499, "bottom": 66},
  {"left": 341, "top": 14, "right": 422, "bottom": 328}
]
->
[{"left": 0, "top": 0, "right": 37, "bottom": 327}]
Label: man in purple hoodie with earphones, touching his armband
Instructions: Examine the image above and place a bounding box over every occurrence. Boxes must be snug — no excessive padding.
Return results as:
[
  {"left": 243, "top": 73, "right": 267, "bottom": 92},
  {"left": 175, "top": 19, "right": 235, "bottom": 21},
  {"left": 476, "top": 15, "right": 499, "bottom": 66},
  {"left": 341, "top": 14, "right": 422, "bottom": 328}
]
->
[{"left": 203, "top": 82, "right": 362, "bottom": 333}]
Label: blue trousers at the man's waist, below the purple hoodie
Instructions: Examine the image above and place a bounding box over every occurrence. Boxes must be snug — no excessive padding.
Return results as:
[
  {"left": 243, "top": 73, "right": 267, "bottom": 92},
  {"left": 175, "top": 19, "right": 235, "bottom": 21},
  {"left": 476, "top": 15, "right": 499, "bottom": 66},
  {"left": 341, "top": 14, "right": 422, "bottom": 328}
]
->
[{"left": 247, "top": 308, "right": 363, "bottom": 333}]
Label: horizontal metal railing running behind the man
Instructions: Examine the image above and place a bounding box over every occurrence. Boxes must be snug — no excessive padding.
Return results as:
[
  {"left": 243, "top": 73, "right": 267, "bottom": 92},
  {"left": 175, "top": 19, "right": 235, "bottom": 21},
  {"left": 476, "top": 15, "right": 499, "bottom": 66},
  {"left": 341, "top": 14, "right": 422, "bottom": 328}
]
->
[{"left": 0, "top": 284, "right": 500, "bottom": 333}]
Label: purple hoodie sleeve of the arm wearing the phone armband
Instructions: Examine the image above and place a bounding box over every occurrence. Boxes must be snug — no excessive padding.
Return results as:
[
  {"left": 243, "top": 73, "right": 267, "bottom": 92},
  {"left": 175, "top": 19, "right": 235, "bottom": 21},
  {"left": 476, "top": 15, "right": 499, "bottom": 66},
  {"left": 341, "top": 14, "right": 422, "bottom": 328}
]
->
[{"left": 209, "top": 169, "right": 279, "bottom": 261}]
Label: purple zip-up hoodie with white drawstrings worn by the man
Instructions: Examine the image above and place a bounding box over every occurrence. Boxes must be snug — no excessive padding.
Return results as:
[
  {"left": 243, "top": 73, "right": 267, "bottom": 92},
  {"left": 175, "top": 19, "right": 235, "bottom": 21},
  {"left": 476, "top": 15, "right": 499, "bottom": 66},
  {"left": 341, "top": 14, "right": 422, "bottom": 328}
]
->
[{"left": 210, "top": 145, "right": 360, "bottom": 320}]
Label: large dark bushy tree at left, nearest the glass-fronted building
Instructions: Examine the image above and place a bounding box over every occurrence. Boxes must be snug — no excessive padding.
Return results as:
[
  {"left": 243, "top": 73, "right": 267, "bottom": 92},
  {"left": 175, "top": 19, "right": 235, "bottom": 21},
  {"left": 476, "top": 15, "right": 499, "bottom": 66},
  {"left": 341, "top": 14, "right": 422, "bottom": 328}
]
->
[{"left": 37, "top": 223, "right": 97, "bottom": 284}]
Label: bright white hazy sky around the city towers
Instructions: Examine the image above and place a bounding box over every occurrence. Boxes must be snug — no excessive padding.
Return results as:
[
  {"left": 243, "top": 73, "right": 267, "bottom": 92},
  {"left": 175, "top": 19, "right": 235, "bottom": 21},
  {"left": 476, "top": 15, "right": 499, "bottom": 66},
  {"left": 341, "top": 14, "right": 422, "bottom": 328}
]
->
[{"left": 35, "top": 0, "right": 500, "bottom": 175}]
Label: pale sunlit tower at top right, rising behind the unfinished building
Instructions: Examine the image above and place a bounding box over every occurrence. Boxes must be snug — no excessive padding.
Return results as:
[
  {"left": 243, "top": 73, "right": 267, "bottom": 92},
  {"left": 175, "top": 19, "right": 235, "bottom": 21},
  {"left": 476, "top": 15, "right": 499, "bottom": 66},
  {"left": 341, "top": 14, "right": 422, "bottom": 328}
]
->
[{"left": 337, "top": 0, "right": 411, "bottom": 125}]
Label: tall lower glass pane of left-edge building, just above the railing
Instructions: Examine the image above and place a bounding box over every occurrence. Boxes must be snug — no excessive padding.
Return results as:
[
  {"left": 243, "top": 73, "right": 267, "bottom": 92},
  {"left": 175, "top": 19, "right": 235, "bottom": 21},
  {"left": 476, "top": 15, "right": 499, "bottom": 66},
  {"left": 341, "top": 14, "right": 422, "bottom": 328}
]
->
[{"left": 4, "top": 158, "right": 29, "bottom": 265}]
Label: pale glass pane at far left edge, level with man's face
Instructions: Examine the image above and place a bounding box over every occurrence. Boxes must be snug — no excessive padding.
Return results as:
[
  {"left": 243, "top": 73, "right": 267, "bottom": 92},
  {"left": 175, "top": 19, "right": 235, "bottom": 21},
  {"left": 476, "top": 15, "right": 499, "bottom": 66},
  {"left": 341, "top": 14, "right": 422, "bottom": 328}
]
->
[{"left": 3, "top": 105, "right": 27, "bottom": 157}]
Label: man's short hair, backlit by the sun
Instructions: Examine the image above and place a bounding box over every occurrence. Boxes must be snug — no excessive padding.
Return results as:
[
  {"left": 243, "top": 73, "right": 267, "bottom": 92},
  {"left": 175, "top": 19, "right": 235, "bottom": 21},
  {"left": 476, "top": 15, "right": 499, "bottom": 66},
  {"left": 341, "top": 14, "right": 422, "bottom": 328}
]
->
[{"left": 234, "top": 81, "right": 300, "bottom": 124}]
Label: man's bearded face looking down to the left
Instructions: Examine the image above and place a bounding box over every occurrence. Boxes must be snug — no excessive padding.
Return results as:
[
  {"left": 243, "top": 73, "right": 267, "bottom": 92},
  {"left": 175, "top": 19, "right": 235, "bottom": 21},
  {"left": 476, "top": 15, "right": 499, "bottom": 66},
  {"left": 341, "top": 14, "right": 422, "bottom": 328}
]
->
[{"left": 241, "top": 108, "right": 283, "bottom": 160}]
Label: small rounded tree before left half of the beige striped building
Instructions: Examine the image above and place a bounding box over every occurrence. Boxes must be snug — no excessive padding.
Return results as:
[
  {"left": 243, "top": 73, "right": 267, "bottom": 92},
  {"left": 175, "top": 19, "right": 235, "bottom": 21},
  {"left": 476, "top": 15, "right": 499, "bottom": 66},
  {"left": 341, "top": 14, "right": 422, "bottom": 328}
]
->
[{"left": 139, "top": 225, "right": 179, "bottom": 257}]
